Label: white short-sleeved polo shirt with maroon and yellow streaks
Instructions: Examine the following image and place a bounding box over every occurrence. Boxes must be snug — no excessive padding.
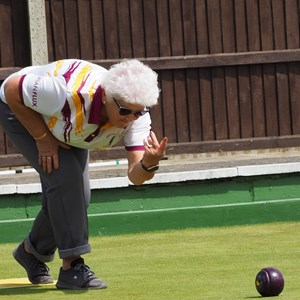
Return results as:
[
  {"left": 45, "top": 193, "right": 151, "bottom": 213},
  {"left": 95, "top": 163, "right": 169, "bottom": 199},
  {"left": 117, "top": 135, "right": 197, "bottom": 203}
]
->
[{"left": 0, "top": 59, "right": 151, "bottom": 151}]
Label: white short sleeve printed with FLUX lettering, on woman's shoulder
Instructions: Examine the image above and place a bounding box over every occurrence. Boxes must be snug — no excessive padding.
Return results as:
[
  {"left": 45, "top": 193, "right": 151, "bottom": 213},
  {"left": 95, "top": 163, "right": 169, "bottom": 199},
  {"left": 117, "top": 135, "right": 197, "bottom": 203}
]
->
[{"left": 19, "top": 74, "right": 67, "bottom": 116}]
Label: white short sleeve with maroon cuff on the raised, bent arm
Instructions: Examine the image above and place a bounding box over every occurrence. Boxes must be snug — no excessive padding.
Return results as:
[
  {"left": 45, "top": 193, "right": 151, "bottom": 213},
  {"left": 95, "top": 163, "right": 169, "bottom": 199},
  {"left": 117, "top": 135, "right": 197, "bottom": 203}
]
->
[{"left": 124, "top": 113, "right": 151, "bottom": 151}]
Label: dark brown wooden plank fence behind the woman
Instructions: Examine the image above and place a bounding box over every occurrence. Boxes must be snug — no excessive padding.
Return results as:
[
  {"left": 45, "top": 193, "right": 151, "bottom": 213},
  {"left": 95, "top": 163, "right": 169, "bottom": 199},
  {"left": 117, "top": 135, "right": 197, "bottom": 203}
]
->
[{"left": 0, "top": 0, "right": 300, "bottom": 165}]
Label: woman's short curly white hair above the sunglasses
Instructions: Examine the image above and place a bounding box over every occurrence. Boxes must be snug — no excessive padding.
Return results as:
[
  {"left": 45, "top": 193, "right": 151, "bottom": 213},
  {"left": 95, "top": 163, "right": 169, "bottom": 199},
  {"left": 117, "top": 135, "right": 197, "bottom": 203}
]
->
[{"left": 101, "top": 59, "right": 160, "bottom": 107}]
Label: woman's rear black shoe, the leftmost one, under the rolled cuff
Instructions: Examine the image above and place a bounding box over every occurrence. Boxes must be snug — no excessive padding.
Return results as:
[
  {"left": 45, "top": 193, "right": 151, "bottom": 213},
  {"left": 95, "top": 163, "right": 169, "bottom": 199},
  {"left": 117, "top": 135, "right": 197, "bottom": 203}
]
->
[{"left": 13, "top": 242, "right": 53, "bottom": 284}]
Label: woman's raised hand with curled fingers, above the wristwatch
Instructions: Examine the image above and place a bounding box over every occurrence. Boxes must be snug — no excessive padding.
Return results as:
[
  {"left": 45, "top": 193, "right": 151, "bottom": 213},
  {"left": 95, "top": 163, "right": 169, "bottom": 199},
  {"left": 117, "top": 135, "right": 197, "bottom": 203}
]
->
[{"left": 143, "top": 131, "right": 168, "bottom": 167}]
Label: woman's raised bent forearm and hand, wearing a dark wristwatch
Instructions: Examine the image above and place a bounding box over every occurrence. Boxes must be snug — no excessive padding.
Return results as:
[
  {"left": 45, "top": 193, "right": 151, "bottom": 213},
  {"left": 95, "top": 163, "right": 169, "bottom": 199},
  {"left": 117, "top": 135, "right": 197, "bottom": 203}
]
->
[{"left": 127, "top": 131, "right": 168, "bottom": 185}]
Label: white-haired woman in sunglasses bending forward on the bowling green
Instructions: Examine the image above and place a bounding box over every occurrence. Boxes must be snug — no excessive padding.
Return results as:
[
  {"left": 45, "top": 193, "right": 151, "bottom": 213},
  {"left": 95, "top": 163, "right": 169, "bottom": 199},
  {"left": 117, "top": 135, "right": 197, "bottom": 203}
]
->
[{"left": 0, "top": 59, "right": 167, "bottom": 289}]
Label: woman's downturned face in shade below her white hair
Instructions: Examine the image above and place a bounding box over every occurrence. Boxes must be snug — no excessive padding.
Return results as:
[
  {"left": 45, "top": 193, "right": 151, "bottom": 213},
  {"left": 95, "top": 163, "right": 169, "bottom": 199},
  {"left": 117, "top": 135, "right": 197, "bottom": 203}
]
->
[{"left": 104, "top": 96, "right": 144, "bottom": 128}]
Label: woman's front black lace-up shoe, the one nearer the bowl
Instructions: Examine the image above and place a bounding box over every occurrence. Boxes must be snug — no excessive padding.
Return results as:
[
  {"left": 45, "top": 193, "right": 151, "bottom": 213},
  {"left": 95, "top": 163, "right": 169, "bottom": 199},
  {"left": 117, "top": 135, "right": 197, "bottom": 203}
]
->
[{"left": 56, "top": 258, "right": 107, "bottom": 290}]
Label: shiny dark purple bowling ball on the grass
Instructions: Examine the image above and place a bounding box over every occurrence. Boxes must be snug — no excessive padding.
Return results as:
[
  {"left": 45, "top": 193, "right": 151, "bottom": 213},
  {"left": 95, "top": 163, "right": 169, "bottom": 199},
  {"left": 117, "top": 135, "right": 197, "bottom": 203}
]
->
[{"left": 255, "top": 267, "right": 284, "bottom": 297}]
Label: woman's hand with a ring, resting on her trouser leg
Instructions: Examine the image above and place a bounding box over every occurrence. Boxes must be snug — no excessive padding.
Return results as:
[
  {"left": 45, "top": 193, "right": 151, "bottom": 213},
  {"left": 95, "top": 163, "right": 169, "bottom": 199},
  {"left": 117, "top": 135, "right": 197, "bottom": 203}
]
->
[{"left": 36, "top": 133, "right": 70, "bottom": 174}]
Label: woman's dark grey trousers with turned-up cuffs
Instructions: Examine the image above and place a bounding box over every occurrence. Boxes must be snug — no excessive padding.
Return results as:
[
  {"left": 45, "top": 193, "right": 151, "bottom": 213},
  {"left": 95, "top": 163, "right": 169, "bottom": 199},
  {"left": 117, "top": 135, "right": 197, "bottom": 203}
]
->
[{"left": 0, "top": 99, "right": 91, "bottom": 262}]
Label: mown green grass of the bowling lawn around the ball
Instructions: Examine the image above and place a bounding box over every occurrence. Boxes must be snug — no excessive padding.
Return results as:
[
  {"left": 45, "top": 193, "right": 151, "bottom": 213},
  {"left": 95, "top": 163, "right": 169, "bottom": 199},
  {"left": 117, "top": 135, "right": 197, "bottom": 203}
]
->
[{"left": 0, "top": 223, "right": 300, "bottom": 300}]
